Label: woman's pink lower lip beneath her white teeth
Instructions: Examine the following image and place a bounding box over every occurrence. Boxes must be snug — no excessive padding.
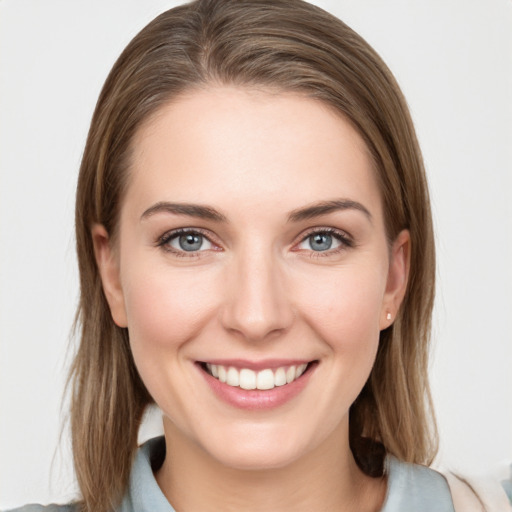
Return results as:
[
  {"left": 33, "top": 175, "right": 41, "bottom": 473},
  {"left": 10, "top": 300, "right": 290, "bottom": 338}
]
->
[{"left": 198, "top": 362, "right": 317, "bottom": 411}]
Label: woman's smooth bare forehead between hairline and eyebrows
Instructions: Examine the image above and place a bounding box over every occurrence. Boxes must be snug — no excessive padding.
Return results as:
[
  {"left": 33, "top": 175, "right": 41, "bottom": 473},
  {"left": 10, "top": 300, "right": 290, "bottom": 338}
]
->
[{"left": 126, "top": 87, "right": 380, "bottom": 222}]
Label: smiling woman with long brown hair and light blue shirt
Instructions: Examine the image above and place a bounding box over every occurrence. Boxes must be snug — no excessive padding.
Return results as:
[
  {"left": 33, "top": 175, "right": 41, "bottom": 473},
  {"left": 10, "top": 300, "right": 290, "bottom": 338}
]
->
[{"left": 5, "top": 1, "right": 512, "bottom": 512}]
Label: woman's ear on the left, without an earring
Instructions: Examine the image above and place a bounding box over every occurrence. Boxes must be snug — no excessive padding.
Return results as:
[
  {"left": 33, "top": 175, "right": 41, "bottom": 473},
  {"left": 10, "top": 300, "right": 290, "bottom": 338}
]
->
[{"left": 91, "top": 224, "right": 128, "bottom": 327}]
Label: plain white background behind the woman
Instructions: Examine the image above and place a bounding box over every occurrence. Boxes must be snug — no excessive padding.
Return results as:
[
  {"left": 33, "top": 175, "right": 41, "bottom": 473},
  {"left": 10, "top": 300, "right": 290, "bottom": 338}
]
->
[{"left": 0, "top": 0, "right": 512, "bottom": 508}]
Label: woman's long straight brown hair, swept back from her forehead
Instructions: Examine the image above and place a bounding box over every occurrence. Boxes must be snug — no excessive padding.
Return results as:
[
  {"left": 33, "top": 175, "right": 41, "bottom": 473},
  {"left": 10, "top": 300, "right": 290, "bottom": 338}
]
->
[{"left": 70, "top": 0, "right": 437, "bottom": 512}]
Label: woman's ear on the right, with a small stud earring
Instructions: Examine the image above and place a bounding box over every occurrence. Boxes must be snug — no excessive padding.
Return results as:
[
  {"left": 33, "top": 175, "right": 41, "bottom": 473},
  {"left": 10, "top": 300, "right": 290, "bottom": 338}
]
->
[{"left": 380, "top": 229, "right": 411, "bottom": 330}]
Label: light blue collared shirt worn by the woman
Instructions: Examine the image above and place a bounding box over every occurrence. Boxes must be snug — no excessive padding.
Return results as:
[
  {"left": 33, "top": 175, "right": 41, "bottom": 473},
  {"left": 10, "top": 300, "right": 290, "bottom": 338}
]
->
[{"left": 4, "top": 437, "right": 476, "bottom": 512}]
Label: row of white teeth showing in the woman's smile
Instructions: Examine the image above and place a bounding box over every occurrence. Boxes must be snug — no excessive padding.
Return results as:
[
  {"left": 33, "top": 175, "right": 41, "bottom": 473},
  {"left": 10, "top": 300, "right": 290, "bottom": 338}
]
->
[{"left": 201, "top": 361, "right": 315, "bottom": 390}]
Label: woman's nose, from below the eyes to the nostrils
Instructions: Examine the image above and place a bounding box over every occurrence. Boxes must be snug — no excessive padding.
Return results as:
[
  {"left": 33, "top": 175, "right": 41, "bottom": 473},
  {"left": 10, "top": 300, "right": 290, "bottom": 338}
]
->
[{"left": 221, "top": 246, "right": 295, "bottom": 341}]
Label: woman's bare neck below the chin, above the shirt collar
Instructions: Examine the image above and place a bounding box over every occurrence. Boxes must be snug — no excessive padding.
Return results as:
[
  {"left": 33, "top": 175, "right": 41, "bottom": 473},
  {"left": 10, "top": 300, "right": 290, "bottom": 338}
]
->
[{"left": 156, "top": 421, "right": 386, "bottom": 512}]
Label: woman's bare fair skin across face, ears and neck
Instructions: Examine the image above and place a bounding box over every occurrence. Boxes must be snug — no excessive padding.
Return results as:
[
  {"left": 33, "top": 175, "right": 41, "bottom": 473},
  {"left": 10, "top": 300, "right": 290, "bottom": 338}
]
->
[{"left": 92, "top": 87, "right": 409, "bottom": 512}]
